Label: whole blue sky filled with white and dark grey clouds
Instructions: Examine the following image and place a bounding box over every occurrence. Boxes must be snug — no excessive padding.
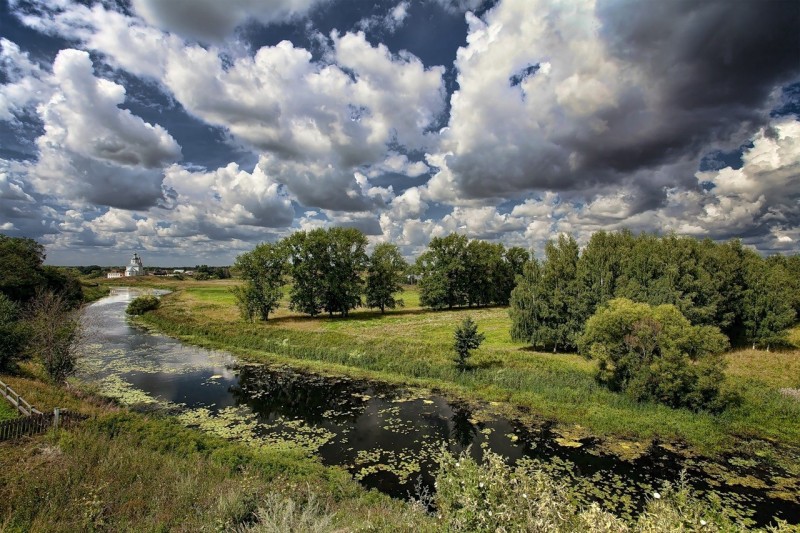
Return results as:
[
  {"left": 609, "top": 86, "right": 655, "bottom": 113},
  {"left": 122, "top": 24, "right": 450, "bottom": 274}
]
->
[{"left": 0, "top": 0, "right": 800, "bottom": 266}]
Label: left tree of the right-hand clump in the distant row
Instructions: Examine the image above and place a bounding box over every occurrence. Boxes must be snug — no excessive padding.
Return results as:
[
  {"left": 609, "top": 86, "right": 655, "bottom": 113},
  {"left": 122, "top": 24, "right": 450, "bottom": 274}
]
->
[{"left": 417, "top": 233, "right": 468, "bottom": 309}]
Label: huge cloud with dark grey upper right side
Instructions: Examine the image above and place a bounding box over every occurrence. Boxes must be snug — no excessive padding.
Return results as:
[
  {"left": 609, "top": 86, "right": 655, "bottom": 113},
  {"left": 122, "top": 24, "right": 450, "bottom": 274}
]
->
[{"left": 430, "top": 0, "right": 800, "bottom": 209}]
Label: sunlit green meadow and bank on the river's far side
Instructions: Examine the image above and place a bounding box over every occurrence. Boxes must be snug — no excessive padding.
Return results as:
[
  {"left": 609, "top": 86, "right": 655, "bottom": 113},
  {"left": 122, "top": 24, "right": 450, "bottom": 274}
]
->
[{"left": 139, "top": 281, "right": 800, "bottom": 460}]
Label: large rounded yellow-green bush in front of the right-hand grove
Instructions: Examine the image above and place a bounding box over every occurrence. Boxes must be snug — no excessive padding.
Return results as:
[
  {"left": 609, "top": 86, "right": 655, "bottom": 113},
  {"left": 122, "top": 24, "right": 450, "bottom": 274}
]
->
[{"left": 580, "top": 298, "right": 728, "bottom": 410}]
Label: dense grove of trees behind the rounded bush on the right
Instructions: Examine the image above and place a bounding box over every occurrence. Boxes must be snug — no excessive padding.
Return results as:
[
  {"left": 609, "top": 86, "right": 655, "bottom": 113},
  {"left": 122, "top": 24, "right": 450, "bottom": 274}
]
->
[{"left": 510, "top": 231, "right": 800, "bottom": 351}]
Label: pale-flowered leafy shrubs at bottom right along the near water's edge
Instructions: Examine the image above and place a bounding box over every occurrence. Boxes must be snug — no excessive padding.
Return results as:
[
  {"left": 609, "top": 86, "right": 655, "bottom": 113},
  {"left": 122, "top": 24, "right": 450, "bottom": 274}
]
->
[{"left": 435, "top": 450, "right": 780, "bottom": 533}]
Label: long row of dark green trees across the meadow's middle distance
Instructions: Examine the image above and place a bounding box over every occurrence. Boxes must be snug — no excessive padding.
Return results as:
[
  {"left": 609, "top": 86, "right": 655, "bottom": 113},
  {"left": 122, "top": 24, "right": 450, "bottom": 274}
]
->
[{"left": 233, "top": 228, "right": 529, "bottom": 321}]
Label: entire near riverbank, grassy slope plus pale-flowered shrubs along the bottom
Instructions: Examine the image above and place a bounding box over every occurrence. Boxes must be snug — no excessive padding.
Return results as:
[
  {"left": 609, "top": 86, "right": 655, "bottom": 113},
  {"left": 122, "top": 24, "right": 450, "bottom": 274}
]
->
[{"left": 0, "top": 366, "right": 796, "bottom": 533}]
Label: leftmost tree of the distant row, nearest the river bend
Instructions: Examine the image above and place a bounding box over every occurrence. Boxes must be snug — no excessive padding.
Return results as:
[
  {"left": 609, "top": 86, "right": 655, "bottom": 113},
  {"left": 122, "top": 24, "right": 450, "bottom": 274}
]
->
[{"left": 232, "top": 242, "right": 288, "bottom": 321}]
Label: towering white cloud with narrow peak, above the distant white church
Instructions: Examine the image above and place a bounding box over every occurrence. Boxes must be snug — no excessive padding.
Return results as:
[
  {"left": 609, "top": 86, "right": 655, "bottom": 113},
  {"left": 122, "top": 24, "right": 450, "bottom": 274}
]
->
[{"left": 29, "top": 49, "right": 181, "bottom": 209}]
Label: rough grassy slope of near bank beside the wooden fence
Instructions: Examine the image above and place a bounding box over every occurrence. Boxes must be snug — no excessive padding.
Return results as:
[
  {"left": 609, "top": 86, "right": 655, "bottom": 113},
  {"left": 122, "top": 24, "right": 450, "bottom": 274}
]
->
[{"left": 0, "top": 376, "right": 435, "bottom": 531}]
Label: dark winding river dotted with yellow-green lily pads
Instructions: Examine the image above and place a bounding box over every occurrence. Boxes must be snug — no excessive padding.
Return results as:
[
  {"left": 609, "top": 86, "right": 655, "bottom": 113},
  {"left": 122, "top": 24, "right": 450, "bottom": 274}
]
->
[{"left": 81, "top": 289, "right": 800, "bottom": 525}]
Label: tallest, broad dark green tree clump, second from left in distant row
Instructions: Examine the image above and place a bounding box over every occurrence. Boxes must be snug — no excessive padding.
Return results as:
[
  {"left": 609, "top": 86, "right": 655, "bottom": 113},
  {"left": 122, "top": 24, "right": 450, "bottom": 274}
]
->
[{"left": 282, "top": 228, "right": 368, "bottom": 316}]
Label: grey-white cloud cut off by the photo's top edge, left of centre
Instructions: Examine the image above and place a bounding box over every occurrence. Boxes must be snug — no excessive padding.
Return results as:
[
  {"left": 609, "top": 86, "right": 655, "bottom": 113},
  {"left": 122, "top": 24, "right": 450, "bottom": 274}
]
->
[{"left": 132, "top": 0, "right": 327, "bottom": 41}]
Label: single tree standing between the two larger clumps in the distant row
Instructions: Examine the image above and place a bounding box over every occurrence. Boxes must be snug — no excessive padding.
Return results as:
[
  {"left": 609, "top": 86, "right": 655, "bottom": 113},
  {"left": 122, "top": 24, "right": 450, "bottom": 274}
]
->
[{"left": 365, "top": 243, "right": 408, "bottom": 313}]
